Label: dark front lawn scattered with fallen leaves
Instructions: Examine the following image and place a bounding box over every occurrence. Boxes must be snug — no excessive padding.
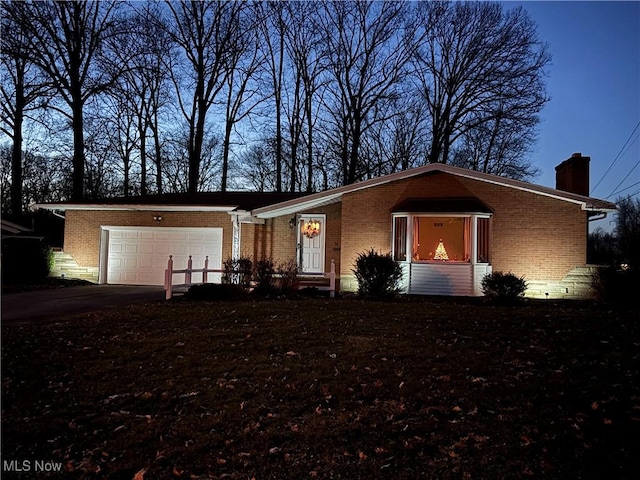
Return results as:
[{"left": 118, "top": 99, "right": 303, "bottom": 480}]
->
[{"left": 2, "top": 298, "right": 640, "bottom": 480}]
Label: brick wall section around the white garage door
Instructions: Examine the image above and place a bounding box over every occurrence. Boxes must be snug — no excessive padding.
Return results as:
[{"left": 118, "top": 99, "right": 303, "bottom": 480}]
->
[{"left": 64, "top": 210, "right": 232, "bottom": 267}]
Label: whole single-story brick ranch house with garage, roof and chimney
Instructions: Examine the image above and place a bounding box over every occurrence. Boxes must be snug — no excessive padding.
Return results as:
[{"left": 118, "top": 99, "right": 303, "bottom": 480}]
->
[{"left": 38, "top": 154, "right": 615, "bottom": 297}]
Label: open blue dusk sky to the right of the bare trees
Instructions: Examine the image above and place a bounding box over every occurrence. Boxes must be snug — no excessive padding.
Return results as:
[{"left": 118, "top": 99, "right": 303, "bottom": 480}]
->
[{"left": 505, "top": 1, "right": 640, "bottom": 228}]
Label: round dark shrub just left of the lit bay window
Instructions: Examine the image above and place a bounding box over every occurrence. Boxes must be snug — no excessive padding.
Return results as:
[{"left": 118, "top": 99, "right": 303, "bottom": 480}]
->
[{"left": 352, "top": 248, "right": 402, "bottom": 298}]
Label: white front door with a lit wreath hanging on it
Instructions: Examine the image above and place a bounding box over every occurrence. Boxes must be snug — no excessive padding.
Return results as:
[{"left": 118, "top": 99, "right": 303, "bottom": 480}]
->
[{"left": 298, "top": 214, "right": 326, "bottom": 274}]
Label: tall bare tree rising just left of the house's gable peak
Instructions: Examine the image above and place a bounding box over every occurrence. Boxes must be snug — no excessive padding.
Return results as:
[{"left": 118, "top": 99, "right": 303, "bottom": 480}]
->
[{"left": 319, "top": 1, "right": 412, "bottom": 184}]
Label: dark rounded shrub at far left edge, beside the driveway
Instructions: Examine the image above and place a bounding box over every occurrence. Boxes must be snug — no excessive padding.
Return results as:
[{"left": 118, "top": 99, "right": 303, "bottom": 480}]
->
[{"left": 2, "top": 237, "right": 53, "bottom": 284}]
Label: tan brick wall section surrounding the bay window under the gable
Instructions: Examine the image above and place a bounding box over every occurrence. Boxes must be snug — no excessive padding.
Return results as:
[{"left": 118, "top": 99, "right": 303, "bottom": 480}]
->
[{"left": 340, "top": 173, "right": 587, "bottom": 289}]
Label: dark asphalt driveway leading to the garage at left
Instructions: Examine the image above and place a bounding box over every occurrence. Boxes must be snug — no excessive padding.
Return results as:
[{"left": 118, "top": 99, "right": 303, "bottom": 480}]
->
[{"left": 0, "top": 285, "right": 164, "bottom": 326}]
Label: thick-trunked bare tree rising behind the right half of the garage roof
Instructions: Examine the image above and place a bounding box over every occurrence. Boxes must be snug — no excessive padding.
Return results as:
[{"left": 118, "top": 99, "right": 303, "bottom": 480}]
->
[{"left": 164, "top": 0, "right": 243, "bottom": 193}]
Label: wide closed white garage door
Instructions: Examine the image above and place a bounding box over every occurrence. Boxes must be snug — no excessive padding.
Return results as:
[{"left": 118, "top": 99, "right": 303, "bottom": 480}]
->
[{"left": 102, "top": 227, "right": 222, "bottom": 285}]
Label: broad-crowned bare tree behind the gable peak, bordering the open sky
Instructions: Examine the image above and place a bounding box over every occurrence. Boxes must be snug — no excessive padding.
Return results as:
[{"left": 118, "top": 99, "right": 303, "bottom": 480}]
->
[{"left": 414, "top": 2, "right": 550, "bottom": 169}]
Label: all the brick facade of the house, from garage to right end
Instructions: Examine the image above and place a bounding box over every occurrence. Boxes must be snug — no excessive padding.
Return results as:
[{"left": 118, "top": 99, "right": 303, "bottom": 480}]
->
[{"left": 65, "top": 173, "right": 587, "bottom": 290}]
